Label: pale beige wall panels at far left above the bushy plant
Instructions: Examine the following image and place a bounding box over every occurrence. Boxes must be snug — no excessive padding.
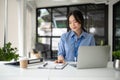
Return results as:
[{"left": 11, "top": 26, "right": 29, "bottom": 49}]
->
[{"left": 0, "top": 0, "right": 18, "bottom": 47}]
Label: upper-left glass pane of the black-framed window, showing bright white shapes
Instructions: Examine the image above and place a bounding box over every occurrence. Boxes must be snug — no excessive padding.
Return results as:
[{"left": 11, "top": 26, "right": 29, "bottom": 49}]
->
[{"left": 37, "top": 9, "right": 51, "bottom": 36}]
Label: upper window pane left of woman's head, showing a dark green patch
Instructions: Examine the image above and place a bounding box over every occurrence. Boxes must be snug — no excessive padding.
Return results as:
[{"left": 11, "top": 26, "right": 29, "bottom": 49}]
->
[{"left": 52, "top": 7, "right": 67, "bottom": 36}]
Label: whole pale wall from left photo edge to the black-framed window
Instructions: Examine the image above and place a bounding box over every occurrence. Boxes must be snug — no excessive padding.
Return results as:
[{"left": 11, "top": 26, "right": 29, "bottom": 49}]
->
[{"left": 0, "top": 0, "right": 36, "bottom": 56}]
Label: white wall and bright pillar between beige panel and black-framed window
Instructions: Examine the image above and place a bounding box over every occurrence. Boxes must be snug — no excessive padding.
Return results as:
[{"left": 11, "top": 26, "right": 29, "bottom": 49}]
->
[{"left": 18, "top": 0, "right": 36, "bottom": 56}]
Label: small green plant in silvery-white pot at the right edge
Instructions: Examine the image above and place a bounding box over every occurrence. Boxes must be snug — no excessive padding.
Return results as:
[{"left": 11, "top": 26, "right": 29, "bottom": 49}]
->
[{"left": 113, "top": 50, "right": 120, "bottom": 70}]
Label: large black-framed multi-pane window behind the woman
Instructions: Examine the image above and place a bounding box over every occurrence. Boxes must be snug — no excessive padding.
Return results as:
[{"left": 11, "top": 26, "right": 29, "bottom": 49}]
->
[{"left": 36, "top": 4, "right": 108, "bottom": 58}]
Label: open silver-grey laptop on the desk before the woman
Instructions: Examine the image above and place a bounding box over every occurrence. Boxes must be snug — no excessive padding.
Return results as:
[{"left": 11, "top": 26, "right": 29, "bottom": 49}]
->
[{"left": 76, "top": 46, "right": 110, "bottom": 69}]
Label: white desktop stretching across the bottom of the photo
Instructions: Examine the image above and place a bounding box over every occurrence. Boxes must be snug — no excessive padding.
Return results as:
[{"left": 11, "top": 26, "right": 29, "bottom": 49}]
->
[{"left": 0, "top": 62, "right": 120, "bottom": 80}]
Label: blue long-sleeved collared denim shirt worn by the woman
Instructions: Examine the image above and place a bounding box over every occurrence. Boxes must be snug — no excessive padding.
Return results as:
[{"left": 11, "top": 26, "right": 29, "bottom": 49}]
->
[{"left": 58, "top": 31, "right": 95, "bottom": 61}]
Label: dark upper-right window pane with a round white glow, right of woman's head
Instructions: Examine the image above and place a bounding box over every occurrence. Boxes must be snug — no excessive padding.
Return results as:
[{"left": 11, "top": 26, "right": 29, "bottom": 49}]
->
[{"left": 87, "top": 5, "right": 105, "bottom": 36}]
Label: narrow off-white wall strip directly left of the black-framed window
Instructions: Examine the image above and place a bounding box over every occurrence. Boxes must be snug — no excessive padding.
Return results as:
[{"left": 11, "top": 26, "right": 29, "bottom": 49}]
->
[{"left": 25, "top": 4, "right": 36, "bottom": 56}]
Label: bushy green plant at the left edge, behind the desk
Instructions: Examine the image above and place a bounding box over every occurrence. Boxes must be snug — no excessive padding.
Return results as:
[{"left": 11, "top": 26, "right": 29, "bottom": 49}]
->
[{"left": 0, "top": 42, "right": 19, "bottom": 61}]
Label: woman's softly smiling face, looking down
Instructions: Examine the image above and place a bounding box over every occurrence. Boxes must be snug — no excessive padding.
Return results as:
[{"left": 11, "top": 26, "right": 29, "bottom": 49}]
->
[{"left": 69, "top": 15, "right": 81, "bottom": 32}]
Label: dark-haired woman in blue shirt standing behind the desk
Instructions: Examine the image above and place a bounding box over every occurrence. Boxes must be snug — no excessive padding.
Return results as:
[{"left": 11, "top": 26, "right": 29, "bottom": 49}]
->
[{"left": 55, "top": 10, "right": 95, "bottom": 63}]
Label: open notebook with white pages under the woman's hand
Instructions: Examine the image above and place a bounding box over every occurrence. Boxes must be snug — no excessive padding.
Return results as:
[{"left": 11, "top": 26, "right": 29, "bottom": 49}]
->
[{"left": 38, "top": 61, "right": 67, "bottom": 69}]
